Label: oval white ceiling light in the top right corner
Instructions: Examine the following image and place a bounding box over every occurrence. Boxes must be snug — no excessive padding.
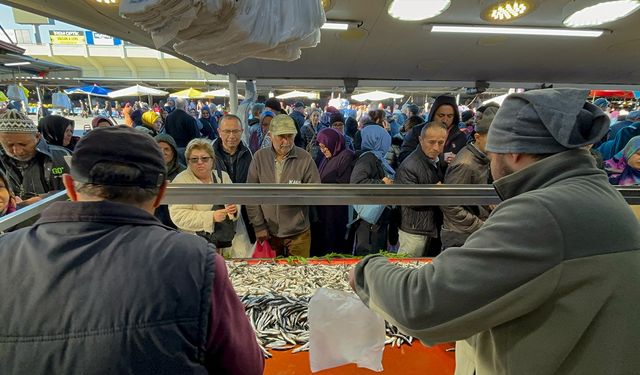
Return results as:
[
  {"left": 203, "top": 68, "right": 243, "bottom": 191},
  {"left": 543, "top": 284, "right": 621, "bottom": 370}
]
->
[{"left": 562, "top": 0, "right": 640, "bottom": 27}]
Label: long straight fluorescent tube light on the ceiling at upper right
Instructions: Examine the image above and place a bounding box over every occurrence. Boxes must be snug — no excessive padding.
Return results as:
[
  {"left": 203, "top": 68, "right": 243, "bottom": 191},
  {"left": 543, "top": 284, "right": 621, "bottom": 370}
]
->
[{"left": 431, "top": 25, "right": 605, "bottom": 38}]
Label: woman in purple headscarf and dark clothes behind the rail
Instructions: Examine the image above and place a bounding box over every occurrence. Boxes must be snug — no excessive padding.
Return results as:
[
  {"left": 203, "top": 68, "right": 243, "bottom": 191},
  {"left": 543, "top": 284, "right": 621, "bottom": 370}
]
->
[{"left": 311, "top": 129, "right": 355, "bottom": 256}]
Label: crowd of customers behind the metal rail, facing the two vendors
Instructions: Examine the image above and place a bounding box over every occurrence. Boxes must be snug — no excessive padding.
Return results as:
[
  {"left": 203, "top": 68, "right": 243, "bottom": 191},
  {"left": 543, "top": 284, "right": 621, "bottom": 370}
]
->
[{"left": 0, "top": 95, "right": 640, "bottom": 257}]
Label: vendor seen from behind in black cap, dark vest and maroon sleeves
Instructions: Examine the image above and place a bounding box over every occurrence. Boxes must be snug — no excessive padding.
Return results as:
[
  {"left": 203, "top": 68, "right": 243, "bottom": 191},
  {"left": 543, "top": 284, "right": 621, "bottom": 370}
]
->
[{"left": 0, "top": 127, "right": 264, "bottom": 375}]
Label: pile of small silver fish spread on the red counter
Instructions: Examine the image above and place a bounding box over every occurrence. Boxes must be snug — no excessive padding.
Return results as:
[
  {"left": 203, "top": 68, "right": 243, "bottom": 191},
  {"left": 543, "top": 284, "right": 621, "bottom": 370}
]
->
[{"left": 227, "top": 261, "right": 423, "bottom": 358}]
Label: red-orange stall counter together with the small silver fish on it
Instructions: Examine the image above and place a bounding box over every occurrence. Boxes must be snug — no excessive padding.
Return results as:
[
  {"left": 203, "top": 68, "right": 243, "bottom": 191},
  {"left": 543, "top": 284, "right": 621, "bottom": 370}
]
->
[{"left": 227, "top": 258, "right": 455, "bottom": 375}]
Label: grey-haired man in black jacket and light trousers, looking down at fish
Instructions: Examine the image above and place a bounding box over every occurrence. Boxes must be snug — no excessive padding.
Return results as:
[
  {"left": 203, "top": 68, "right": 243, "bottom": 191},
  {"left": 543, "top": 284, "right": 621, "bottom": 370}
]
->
[{"left": 395, "top": 121, "right": 447, "bottom": 257}]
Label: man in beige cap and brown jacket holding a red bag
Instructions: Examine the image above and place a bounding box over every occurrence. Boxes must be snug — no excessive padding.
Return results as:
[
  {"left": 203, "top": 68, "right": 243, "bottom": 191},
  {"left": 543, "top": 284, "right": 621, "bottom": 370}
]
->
[{"left": 247, "top": 115, "right": 320, "bottom": 257}]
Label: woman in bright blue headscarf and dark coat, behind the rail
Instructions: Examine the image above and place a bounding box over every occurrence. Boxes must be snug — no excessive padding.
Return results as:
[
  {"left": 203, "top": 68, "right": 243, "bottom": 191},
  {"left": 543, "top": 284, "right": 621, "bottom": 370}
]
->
[{"left": 350, "top": 126, "right": 395, "bottom": 255}]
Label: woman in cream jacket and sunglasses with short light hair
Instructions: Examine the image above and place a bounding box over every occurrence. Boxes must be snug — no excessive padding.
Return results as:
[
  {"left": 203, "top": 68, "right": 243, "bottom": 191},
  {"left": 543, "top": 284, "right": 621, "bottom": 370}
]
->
[{"left": 169, "top": 138, "right": 252, "bottom": 258}]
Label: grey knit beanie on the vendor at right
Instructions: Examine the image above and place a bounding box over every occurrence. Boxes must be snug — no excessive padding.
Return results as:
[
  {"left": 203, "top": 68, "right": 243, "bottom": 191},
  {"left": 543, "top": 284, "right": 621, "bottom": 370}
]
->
[{"left": 486, "top": 89, "right": 609, "bottom": 154}]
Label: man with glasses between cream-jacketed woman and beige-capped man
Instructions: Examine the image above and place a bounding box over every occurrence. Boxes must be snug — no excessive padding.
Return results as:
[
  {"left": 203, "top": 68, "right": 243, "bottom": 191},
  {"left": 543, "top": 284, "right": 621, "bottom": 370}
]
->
[{"left": 213, "top": 115, "right": 256, "bottom": 243}]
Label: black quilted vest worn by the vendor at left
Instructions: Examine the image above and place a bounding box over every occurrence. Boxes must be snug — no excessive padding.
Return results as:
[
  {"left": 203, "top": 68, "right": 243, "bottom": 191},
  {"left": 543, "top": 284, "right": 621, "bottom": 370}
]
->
[{"left": 0, "top": 202, "right": 215, "bottom": 374}]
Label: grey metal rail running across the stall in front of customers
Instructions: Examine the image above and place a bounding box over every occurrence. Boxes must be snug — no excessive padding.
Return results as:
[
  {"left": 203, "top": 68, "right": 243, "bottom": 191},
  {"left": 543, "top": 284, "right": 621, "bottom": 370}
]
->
[{"left": 0, "top": 184, "right": 640, "bottom": 231}]
